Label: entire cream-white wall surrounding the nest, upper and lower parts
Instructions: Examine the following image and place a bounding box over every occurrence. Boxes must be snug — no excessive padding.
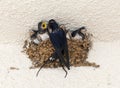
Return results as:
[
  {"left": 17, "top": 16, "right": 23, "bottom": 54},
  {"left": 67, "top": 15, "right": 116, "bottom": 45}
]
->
[{"left": 0, "top": 0, "right": 120, "bottom": 88}]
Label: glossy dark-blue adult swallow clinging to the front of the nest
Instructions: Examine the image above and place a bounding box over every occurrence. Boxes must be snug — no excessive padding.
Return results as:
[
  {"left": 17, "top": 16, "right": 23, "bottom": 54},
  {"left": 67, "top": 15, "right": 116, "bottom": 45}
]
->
[{"left": 48, "top": 19, "right": 70, "bottom": 70}]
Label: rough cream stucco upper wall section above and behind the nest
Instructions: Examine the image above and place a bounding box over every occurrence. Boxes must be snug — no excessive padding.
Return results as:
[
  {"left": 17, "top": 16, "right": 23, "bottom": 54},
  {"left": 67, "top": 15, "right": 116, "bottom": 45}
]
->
[{"left": 0, "top": 0, "right": 120, "bottom": 43}]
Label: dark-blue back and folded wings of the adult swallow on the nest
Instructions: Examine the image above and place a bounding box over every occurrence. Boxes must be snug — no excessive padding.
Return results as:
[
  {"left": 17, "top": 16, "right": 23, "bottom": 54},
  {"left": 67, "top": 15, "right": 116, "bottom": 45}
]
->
[{"left": 49, "top": 30, "right": 69, "bottom": 69}]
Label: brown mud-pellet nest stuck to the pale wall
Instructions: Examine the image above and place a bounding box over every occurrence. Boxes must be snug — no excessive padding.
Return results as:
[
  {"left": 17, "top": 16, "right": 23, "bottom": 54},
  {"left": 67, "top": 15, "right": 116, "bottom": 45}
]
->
[{"left": 24, "top": 35, "right": 99, "bottom": 69}]
